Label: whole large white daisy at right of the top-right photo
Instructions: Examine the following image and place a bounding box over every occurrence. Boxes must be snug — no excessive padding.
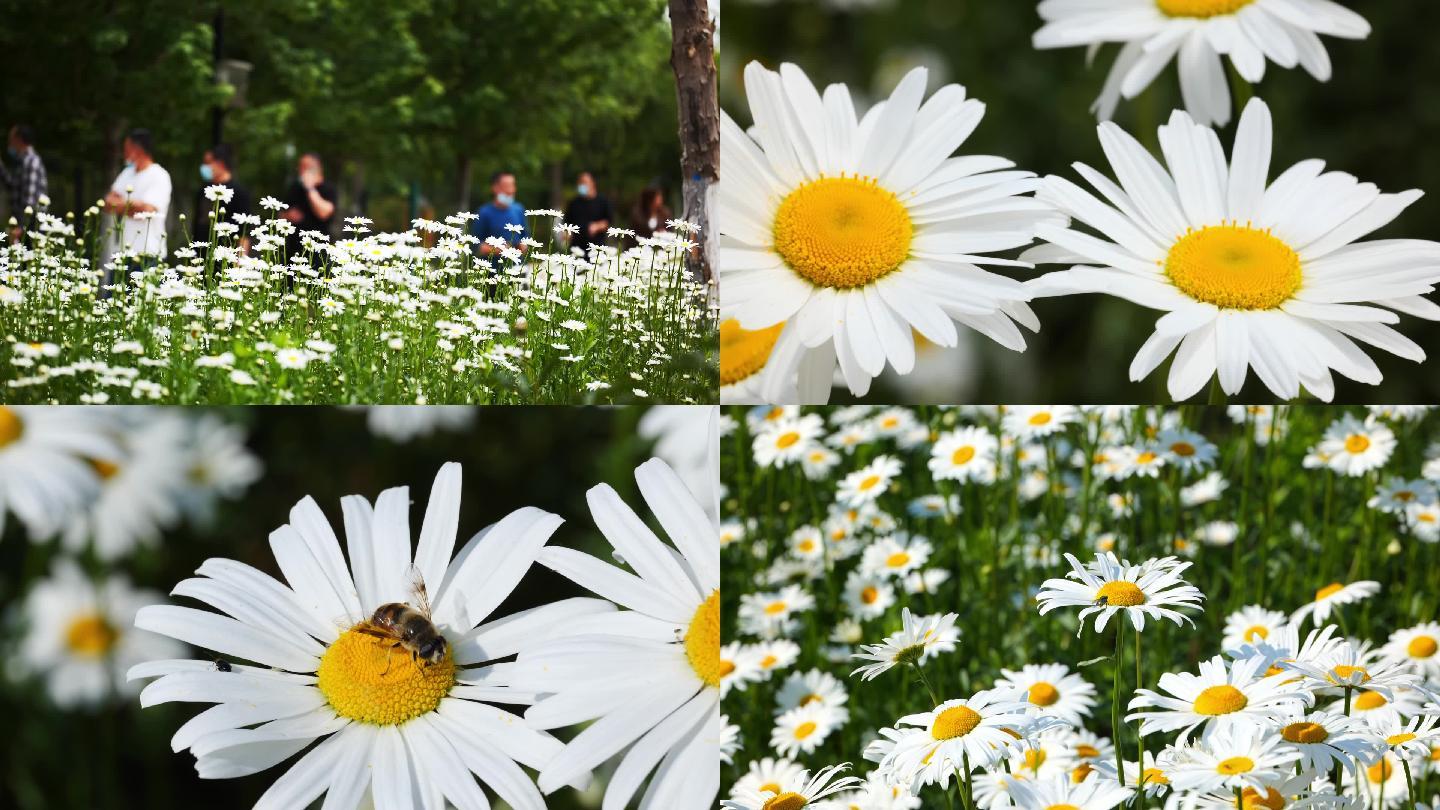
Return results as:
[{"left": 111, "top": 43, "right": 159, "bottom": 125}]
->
[{"left": 1022, "top": 99, "right": 1440, "bottom": 401}]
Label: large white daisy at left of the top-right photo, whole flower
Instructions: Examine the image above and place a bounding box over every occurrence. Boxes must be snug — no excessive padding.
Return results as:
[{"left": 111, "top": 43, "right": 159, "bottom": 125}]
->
[{"left": 719, "top": 63, "right": 1060, "bottom": 402}]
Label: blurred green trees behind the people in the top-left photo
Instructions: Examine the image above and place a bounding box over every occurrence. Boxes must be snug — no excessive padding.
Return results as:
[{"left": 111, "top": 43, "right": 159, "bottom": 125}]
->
[{"left": 0, "top": 0, "right": 680, "bottom": 231}]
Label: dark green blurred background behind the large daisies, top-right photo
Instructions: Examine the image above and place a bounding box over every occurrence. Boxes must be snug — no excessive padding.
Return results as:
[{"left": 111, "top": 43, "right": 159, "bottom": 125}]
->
[{"left": 720, "top": 0, "right": 1440, "bottom": 404}]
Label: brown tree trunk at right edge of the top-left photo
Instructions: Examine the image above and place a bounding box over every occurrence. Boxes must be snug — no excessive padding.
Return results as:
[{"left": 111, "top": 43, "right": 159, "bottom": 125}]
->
[{"left": 670, "top": 0, "right": 720, "bottom": 281}]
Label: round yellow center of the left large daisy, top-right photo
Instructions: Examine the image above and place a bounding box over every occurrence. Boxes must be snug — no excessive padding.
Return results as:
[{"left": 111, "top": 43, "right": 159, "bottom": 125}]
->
[{"left": 775, "top": 177, "right": 914, "bottom": 290}]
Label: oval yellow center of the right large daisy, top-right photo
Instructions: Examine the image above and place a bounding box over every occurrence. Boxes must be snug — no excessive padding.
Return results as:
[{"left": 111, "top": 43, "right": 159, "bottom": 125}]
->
[{"left": 1161, "top": 224, "right": 1300, "bottom": 310}]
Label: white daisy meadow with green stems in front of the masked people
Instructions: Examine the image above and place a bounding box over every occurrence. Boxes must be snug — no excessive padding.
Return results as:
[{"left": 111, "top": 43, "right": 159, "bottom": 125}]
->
[{"left": 0, "top": 201, "right": 716, "bottom": 405}]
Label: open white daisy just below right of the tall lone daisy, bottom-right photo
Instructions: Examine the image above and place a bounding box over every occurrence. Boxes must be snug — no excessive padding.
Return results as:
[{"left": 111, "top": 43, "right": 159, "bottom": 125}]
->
[{"left": 1125, "top": 656, "right": 1310, "bottom": 741}]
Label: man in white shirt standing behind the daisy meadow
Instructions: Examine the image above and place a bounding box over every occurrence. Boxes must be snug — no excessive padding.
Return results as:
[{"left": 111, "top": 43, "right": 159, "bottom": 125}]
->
[{"left": 105, "top": 130, "right": 170, "bottom": 282}]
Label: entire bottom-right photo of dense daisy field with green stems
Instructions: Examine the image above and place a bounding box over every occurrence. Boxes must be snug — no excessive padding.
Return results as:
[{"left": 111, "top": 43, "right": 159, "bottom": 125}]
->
[{"left": 720, "top": 405, "right": 1440, "bottom": 810}]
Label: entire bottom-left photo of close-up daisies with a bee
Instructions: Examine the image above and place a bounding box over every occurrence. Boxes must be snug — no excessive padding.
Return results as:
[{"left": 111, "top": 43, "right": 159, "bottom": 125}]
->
[{"left": 0, "top": 406, "right": 721, "bottom": 810}]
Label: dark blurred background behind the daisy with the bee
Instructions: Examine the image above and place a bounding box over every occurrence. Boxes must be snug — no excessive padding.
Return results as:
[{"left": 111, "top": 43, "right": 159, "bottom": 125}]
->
[{"left": 0, "top": 406, "right": 717, "bottom": 810}]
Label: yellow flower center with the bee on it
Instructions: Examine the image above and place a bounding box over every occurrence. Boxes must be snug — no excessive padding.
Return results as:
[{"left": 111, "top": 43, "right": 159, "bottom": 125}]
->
[{"left": 315, "top": 624, "right": 455, "bottom": 725}]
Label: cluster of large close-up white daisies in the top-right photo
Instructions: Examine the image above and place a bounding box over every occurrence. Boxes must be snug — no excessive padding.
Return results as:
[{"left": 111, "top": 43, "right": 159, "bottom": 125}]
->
[{"left": 719, "top": 0, "right": 1440, "bottom": 404}]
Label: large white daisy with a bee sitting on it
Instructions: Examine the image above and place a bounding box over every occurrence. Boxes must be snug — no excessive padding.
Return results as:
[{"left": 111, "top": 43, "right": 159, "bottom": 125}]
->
[{"left": 128, "top": 464, "right": 578, "bottom": 810}]
